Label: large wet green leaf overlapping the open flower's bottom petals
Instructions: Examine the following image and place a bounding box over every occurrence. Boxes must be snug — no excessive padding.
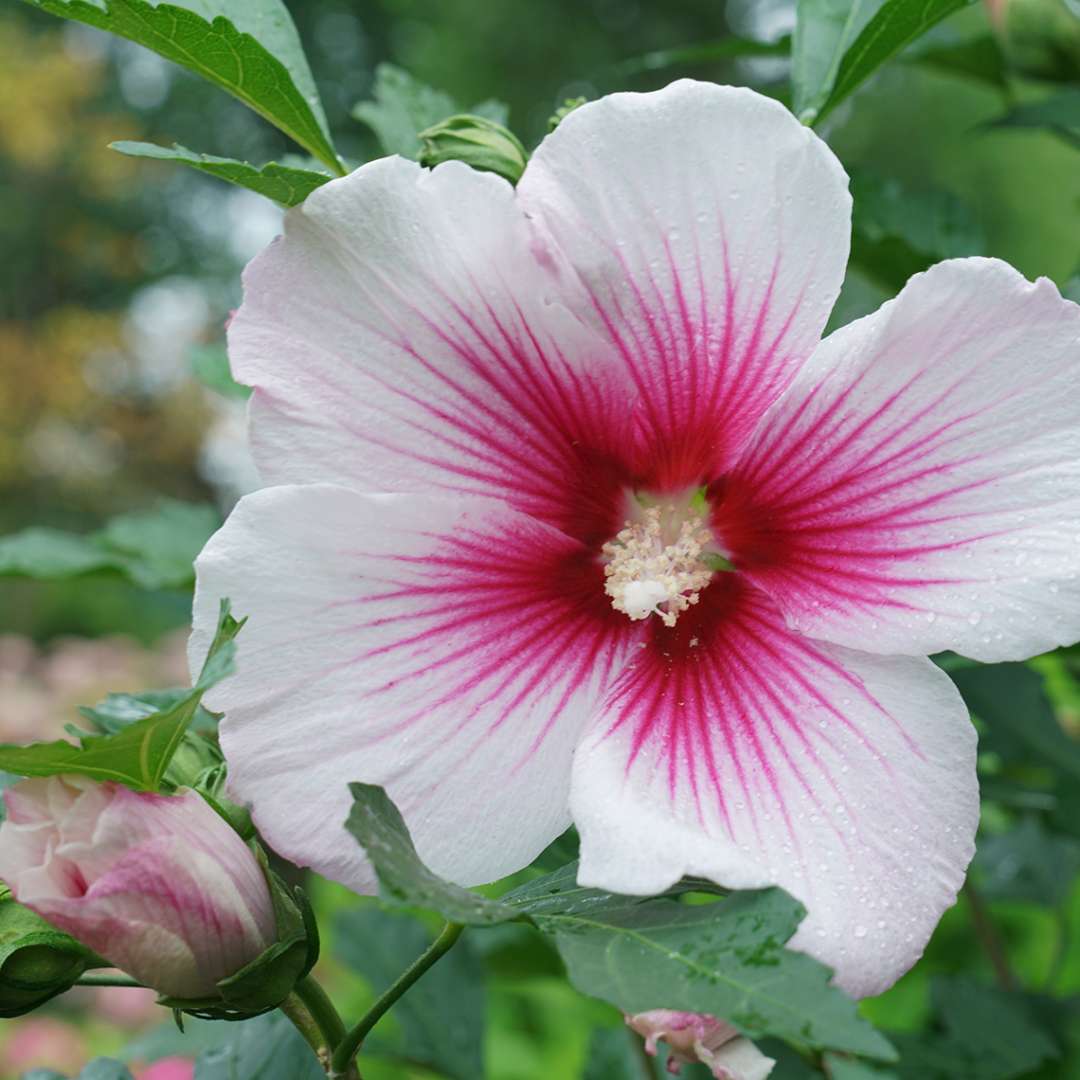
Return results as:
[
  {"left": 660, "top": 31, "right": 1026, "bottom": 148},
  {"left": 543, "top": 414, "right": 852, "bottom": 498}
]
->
[{"left": 347, "top": 784, "right": 893, "bottom": 1059}]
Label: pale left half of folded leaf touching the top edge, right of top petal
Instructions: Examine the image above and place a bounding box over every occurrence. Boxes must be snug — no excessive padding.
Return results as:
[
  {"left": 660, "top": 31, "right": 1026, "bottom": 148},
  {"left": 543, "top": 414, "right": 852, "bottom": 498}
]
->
[{"left": 792, "top": 0, "right": 885, "bottom": 123}]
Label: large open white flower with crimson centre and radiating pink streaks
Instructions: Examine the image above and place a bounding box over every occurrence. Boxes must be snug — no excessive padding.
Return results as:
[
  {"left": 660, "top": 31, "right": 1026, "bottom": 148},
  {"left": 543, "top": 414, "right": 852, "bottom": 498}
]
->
[{"left": 191, "top": 82, "right": 1080, "bottom": 995}]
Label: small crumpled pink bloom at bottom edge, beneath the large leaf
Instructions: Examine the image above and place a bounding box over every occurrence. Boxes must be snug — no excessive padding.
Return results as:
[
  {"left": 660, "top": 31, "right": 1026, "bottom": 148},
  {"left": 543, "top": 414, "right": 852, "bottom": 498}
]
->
[{"left": 626, "top": 1009, "right": 777, "bottom": 1080}]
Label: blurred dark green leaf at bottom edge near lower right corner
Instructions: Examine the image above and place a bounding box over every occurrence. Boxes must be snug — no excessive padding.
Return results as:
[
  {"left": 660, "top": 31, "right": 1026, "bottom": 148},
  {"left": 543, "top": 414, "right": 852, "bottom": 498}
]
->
[{"left": 896, "top": 976, "right": 1059, "bottom": 1080}]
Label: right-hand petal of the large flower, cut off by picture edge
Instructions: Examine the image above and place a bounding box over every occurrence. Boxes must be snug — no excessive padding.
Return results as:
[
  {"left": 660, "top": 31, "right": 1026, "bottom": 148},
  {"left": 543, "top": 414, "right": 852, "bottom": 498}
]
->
[{"left": 717, "top": 259, "right": 1080, "bottom": 661}]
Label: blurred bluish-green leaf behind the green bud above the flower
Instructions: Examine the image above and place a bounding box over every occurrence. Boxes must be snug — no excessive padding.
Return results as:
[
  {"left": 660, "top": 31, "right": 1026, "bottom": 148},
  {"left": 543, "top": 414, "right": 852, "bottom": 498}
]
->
[{"left": 352, "top": 64, "right": 508, "bottom": 161}]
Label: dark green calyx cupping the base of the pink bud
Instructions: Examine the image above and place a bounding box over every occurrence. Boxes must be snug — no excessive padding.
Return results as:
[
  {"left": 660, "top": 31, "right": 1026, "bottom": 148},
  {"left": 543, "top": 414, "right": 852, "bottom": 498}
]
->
[{"left": 159, "top": 842, "right": 319, "bottom": 1020}]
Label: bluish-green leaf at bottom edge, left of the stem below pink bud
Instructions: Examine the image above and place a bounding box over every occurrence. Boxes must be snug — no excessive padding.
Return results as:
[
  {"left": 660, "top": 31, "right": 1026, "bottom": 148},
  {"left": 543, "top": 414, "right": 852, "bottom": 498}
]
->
[{"left": 194, "top": 1012, "right": 326, "bottom": 1080}]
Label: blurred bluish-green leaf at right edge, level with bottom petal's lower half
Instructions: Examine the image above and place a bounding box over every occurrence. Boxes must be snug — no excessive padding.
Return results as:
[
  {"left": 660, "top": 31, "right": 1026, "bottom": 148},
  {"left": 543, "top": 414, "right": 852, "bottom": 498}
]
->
[{"left": 974, "top": 816, "right": 1080, "bottom": 905}]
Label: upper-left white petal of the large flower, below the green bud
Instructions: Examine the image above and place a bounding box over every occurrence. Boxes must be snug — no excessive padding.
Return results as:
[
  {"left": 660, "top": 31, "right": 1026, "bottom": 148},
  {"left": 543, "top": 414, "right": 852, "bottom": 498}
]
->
[{"left": 229, "top": 158, "right": 633, "bottom": 527}]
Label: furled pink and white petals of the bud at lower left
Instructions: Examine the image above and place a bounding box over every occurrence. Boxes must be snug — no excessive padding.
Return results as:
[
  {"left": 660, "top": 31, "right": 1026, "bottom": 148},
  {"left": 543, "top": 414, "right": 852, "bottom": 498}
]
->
[{"left": 0, "top": 777, "right": 275, "bottom": 998}]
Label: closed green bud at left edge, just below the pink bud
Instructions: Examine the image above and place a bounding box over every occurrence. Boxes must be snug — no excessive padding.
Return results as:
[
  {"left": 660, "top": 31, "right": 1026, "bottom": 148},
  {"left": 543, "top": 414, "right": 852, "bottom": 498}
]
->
[{"left": 0, "top": 885, "right": 105, "bottom": 1020}]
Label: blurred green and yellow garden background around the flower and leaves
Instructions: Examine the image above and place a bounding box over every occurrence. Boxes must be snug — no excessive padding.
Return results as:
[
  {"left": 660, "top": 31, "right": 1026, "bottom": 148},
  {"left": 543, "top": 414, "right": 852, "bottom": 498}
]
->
[{"left": 0, "top": 0, "right": 1080, "bottom": 1080}]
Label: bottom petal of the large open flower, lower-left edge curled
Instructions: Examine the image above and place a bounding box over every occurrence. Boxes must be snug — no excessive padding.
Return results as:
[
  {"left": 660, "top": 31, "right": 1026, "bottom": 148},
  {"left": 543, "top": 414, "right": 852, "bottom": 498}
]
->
[{"left": 570, "top": 576, "right": 978, "bottom": 996}]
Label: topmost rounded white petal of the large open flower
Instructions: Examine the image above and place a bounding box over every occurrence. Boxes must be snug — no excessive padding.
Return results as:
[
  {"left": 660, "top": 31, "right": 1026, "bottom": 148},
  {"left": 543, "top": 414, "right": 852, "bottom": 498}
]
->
[{"left": 517, "top": 80, "right": 851, "bottom": 468}]
